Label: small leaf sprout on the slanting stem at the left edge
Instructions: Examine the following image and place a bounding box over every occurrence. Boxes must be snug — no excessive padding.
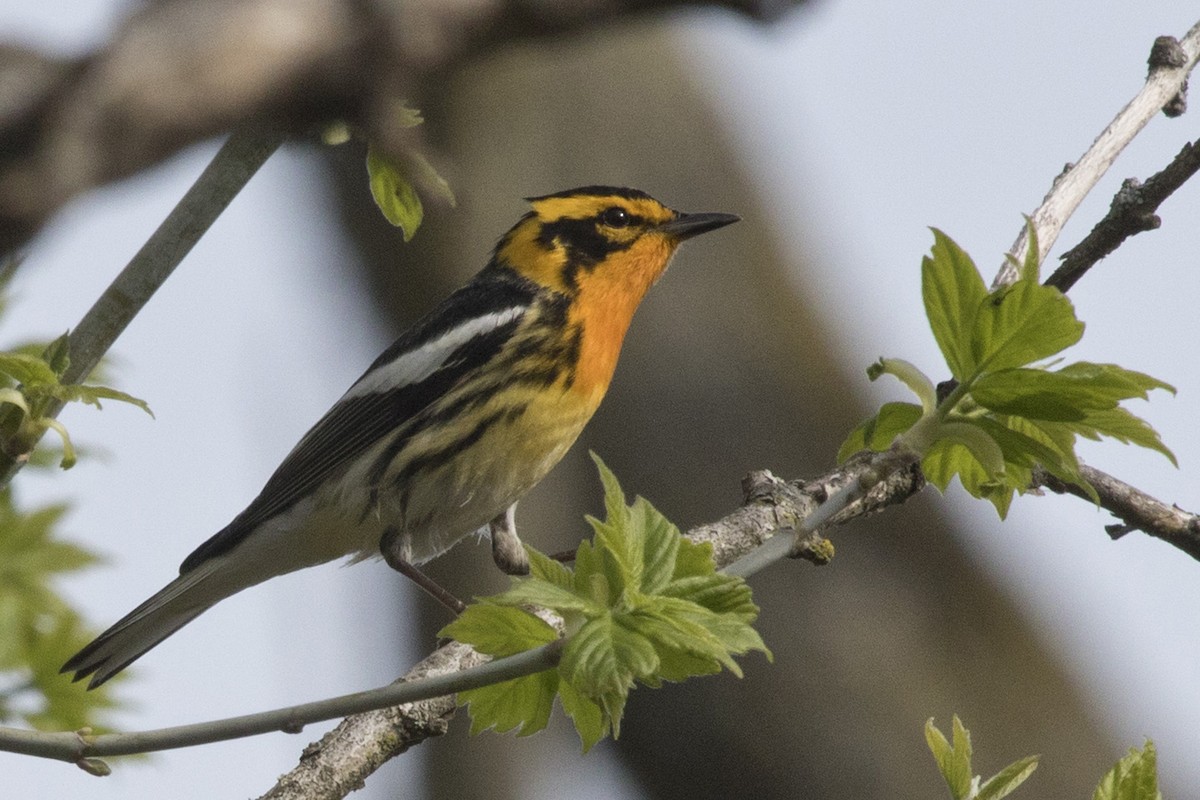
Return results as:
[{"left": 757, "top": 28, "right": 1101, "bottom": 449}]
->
[{"left": 0, "top": 333, "right": 154, "bottom": 469}]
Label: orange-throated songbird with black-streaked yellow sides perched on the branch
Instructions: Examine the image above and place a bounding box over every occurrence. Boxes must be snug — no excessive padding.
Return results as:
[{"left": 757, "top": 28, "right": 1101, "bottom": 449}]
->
[{"left": 62, "top": 186, "right": 738, "bottom": 688}]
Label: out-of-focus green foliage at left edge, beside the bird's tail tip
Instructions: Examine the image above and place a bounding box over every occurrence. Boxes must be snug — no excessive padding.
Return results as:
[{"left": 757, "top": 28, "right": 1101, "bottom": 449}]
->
[{"left": 0, "top": 488, "right": 120, "bottom": 730}]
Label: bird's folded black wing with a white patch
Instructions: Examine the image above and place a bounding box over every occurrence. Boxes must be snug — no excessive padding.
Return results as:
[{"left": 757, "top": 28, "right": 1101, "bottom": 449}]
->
[{"left": 180, "top": 275, "right": 534, "bottom": 573}]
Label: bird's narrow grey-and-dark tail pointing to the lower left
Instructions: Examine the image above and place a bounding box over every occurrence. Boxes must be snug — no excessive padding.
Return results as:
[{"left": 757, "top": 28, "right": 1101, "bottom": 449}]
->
[{"left": 61, "top": 559, "right": 229, "bottom": 688}]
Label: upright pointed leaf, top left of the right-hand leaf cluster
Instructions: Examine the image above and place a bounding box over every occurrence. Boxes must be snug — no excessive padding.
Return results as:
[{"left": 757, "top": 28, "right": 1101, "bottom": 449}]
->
[{"left": 920, "top": 228, "right": 988, "bottom": 381}]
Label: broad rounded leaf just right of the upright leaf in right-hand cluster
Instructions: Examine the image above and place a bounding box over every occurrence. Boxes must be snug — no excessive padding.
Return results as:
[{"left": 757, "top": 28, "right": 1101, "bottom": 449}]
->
[{"left": 969, "top": 281, "right": 1084, "bottom": 380}]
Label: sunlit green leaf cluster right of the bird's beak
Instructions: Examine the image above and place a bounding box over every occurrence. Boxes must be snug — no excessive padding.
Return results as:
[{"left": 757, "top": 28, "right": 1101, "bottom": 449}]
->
[{"left": 839, "top": 228, "right": 1175, "bottom": 517}]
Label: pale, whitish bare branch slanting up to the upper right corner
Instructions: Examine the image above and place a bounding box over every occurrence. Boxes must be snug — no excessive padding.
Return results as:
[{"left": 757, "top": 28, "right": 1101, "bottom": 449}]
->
[{"left": 992, "top": 22, "right": 1200, "bottom": 287}]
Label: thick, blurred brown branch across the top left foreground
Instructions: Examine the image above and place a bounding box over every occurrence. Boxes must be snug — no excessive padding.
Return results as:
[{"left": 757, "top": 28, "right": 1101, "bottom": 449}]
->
[{"left": 0, "top": 0, "right": 802, "bottom": 254}]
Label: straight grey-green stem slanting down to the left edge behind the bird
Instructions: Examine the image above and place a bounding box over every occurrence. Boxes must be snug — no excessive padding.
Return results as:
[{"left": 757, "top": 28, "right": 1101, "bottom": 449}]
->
[{"left": 0, "top": 131, "right": 282, "bottom": 486}]
